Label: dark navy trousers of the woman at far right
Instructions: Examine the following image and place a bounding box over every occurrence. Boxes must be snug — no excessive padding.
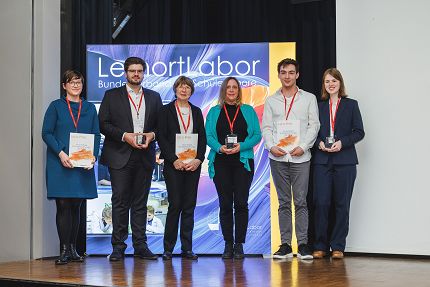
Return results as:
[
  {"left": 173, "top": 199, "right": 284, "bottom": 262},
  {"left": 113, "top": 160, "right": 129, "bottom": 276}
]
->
[{"left": 313, "top": 163, "right": 357, "bottom": 252}]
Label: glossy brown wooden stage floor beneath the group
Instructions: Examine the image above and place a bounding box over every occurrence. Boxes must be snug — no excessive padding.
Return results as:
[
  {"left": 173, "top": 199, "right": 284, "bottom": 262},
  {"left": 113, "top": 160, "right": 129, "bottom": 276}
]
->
[{"left": 0, "top": 256, "right": 430, "bottom": 287}]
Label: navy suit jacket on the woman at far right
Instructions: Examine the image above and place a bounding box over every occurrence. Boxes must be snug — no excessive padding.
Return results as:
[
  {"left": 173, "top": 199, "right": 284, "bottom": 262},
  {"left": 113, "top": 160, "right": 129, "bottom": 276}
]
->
[{"left": 312, "top": 97, "right": 364, "bottom": 165}]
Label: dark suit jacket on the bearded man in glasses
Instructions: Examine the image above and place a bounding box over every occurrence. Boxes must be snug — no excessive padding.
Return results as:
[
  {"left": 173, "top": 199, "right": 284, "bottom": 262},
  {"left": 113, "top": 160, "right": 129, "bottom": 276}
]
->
[{"left": 99, "top": 85, "right": 163, "bottom": 169}]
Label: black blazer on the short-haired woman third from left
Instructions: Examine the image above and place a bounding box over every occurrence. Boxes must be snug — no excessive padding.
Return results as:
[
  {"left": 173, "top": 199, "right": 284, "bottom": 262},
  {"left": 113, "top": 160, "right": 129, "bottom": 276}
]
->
[{"left": 157, "top": 101, "right": 206, "bottom": 164}]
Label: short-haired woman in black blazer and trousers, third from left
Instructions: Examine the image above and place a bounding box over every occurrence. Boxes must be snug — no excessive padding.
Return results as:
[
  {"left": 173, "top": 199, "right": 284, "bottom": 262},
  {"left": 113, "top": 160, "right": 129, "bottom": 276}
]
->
[{"left": 157, "top": 76, "right": 206, "bottom": 260}]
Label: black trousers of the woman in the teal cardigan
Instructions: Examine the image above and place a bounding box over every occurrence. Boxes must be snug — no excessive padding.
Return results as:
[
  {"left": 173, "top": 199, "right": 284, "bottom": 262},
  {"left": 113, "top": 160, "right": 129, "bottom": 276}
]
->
[{"left": 214, "top": 159, "right": 254, "bottom": 243}]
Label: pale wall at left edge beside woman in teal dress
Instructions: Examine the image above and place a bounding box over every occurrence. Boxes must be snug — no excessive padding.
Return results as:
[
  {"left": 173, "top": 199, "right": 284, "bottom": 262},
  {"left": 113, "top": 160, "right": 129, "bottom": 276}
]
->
[{"left": 0, "top": 0, "right": 60, "bottom": 262}]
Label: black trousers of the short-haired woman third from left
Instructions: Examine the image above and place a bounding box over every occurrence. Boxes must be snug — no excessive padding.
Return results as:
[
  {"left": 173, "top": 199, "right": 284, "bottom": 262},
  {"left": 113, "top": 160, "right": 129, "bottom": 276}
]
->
[{"left": 163, "top": 163, "right": 201, "bottom": 252}]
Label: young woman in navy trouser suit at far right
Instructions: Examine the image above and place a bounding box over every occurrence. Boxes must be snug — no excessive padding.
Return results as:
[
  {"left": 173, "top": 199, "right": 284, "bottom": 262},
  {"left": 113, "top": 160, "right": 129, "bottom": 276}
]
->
[{"left": 313, "top": 68, "right": 364, "bottom": 259}]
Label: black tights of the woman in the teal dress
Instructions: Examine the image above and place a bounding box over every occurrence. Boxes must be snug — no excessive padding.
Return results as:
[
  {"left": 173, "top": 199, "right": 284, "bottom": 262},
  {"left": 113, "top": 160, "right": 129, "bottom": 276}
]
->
[{"left": 55, "top": 198, "right": 83, "bottom": 245}]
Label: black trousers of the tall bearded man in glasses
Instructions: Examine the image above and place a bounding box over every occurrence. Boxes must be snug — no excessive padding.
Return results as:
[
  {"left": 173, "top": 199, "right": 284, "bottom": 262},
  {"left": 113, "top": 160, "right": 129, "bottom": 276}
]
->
[{"left": 109, "top": 150, "right": 152, "bottom": 250}]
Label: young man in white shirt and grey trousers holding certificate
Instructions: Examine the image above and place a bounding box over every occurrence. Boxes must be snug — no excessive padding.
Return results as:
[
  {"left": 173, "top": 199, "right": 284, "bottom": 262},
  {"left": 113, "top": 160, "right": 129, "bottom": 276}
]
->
[{"left": 263, "top": 59, "right": 320, "bottom": 259}]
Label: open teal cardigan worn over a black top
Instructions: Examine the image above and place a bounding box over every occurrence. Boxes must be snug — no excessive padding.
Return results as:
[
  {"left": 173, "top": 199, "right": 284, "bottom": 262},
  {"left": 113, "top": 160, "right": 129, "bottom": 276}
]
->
[{"left": 206, "top": 104, "right": 261, "bottom": 178}]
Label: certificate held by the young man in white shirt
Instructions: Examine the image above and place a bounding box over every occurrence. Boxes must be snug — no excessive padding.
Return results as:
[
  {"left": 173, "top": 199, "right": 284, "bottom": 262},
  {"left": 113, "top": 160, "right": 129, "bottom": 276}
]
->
[{"left": 274, "top": 120, "right": 300, "bottom": 153}]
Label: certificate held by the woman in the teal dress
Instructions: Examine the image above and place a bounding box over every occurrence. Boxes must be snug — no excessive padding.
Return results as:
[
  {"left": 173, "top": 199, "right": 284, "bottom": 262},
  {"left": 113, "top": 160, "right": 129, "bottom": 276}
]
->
[{"left": 69, "top": 133, "right": 94, "bottom": 167}]
